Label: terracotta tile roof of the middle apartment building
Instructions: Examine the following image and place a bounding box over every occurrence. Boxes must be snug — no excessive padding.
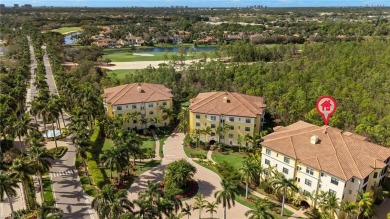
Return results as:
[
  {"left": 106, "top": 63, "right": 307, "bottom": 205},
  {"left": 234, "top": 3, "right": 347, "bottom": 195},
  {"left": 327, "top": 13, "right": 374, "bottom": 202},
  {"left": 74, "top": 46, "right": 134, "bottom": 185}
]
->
[{"left": 189, "top": 92, "right": 266, "bottom": 117}]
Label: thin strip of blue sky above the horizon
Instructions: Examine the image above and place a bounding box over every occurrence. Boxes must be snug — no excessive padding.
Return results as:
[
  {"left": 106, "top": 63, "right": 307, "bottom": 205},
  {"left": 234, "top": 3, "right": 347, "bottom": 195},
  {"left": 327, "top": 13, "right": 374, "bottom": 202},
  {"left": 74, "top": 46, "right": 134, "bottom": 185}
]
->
[{"left": 0, "top": 0, "right": 390, "bottom": 7}]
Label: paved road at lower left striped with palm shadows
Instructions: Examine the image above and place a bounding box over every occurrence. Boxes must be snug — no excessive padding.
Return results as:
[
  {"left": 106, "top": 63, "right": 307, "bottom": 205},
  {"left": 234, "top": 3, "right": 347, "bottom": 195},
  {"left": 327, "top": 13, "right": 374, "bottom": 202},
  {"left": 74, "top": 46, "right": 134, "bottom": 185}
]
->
[{"left": 46, "top": 138, "right": 95, "bottom": 219}]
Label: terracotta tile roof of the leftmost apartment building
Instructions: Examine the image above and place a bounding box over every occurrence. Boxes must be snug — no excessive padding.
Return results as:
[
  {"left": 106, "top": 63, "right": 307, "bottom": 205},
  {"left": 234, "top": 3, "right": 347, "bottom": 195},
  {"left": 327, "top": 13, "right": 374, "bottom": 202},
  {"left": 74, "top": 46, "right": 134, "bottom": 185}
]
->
[{"left": 103, "top": 83, "right": 173, "bottom": 105}]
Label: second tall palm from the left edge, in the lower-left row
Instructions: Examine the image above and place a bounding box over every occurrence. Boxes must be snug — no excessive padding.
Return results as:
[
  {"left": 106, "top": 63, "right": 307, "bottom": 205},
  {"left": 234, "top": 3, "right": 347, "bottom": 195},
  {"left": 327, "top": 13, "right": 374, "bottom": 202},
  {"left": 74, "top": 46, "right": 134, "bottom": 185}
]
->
[{"left": 10, "top": 156, "right": 35, "bottom": 209}]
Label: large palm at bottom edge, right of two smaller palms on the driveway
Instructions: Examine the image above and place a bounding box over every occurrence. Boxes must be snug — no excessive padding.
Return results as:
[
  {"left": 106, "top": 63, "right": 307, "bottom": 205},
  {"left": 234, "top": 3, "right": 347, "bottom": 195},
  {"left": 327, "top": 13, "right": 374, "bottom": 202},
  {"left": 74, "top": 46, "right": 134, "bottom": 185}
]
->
[{"left": 214, "top": 179, "right": 237, "bottom": 219}]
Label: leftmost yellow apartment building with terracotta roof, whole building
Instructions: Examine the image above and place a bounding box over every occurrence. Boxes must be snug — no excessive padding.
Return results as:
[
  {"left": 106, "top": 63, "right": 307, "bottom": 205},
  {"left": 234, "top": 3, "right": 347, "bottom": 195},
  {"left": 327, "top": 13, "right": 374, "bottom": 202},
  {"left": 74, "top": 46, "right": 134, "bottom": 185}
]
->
[{"left": 103, "top": 83, "right": 173, "bottom": 130}]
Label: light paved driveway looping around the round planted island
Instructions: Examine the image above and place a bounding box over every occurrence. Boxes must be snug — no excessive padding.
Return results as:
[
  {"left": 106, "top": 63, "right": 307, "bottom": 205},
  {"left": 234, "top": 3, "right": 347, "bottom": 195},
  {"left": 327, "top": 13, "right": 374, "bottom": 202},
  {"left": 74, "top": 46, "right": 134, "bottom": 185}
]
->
[{"left": 128, "top": 133, "right": 249, "bottom": 219}]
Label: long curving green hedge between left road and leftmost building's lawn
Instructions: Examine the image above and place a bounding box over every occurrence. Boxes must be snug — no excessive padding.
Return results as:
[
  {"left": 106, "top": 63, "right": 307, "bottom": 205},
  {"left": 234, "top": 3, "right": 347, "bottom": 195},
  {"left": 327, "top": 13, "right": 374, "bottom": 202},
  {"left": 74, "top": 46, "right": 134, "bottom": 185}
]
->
[{"left": 87, "top": 121, "right": 107, "bottom": 189}]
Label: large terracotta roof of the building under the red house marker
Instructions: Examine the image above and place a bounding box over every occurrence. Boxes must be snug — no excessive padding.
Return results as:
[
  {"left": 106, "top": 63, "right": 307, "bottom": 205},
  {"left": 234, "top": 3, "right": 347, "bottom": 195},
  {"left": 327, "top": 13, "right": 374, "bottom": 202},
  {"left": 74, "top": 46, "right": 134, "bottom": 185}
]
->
[{"left": 262, "top": 121, "right": 390, "bottom": 180}]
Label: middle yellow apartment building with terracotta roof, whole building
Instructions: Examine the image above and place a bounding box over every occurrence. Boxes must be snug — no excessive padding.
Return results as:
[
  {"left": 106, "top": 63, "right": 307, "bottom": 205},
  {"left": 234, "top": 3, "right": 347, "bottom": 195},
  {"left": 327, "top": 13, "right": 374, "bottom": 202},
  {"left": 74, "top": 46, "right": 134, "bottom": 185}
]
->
[{"left": 189, "top": 92, "right": 266, "bottom": 145}]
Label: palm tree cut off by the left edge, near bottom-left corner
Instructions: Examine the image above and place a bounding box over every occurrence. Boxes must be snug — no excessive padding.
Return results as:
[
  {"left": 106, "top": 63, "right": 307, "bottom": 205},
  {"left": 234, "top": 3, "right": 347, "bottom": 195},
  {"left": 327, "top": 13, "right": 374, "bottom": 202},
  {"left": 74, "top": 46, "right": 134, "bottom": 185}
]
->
[{"left": 0, "top": 170, "right": 19, "bottom": 218}]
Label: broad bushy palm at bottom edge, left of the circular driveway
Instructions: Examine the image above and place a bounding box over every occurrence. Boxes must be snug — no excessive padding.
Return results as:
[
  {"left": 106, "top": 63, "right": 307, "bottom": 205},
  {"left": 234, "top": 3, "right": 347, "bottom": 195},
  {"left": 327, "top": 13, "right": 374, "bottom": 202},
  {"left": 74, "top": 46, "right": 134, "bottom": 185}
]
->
[{"left": 91, "top": 185, "right": 134, "bottom": 218}]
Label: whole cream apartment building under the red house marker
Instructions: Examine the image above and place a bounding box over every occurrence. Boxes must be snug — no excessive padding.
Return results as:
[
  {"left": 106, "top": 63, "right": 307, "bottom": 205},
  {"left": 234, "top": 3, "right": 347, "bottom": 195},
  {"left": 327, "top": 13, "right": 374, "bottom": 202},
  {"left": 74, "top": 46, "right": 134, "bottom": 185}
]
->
[{"left": 261, "top": 121, "right": 390, "bottom": 216}]
